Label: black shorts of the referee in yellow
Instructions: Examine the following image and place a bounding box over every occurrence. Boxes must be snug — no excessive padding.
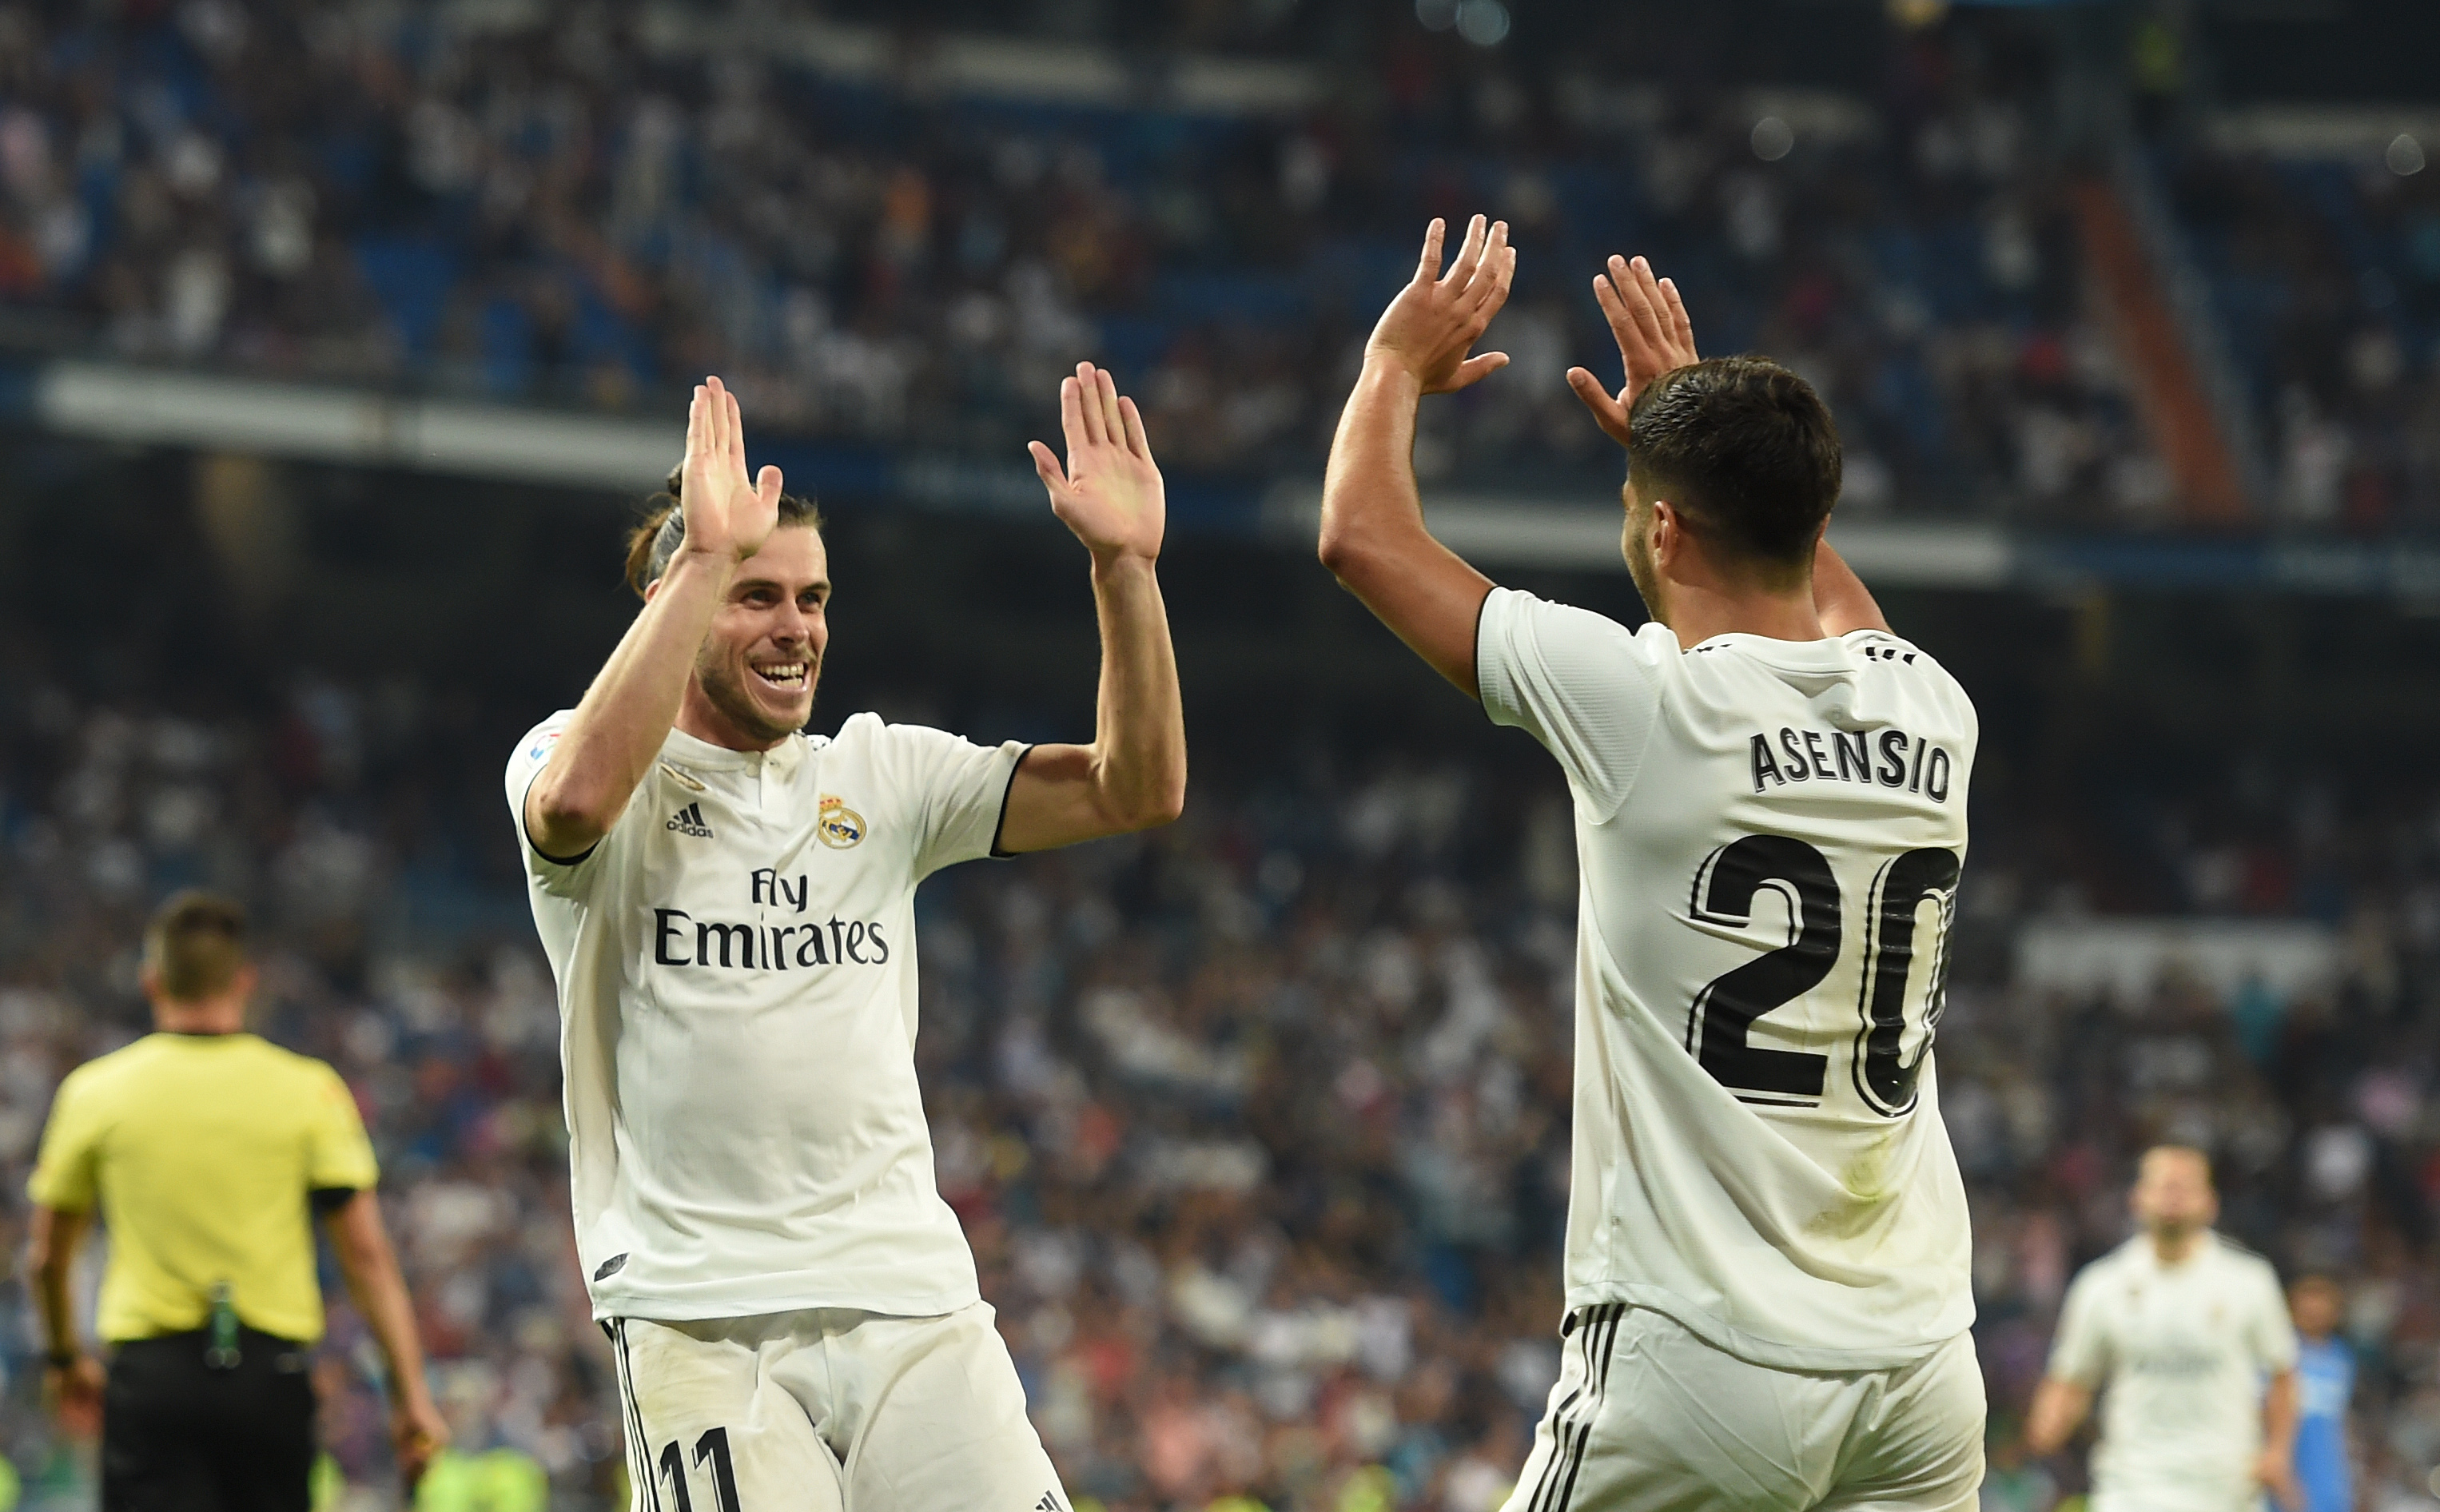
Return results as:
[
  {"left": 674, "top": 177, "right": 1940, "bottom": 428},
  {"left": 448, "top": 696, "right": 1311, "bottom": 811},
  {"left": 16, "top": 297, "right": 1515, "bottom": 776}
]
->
[{"left": 102, "top": 1329, "right": 315, "bottom": 1512}]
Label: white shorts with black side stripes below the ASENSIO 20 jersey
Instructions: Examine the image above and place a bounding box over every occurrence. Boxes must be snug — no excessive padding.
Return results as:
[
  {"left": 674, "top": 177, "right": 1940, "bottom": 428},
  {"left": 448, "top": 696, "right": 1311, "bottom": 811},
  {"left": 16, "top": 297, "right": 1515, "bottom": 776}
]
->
[{"left": 1503, "top": 1303, "right": 1984, "bottom": 1512}]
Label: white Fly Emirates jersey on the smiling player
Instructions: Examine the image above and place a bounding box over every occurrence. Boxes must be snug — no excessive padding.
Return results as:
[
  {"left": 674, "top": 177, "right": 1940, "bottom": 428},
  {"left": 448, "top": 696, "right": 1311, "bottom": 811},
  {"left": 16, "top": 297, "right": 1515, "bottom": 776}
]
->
[{"left": 508, "top": 712, "right": 1025, "bottom": 1322}]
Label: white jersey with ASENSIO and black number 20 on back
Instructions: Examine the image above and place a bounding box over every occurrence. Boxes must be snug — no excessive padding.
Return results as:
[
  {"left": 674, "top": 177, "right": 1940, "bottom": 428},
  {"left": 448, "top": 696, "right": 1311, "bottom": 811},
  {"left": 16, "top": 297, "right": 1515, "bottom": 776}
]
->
[{"left": 1476, "top": 590, "right": 1976, "bottom": 1371}]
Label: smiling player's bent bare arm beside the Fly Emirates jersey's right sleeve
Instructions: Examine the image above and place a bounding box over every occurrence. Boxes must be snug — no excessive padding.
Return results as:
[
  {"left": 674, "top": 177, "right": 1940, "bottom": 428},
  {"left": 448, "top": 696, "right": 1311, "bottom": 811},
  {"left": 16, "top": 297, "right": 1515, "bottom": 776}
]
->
[{"left": 998, "top": 364, "right": 1186, "bottom": 851}]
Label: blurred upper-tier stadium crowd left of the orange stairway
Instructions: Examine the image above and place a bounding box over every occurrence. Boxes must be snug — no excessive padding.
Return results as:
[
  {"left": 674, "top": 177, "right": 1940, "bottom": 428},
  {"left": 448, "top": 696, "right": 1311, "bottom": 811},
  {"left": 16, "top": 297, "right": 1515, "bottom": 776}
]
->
[{"left": 0, "top": 0, "right": 2186, "bottom": 522}]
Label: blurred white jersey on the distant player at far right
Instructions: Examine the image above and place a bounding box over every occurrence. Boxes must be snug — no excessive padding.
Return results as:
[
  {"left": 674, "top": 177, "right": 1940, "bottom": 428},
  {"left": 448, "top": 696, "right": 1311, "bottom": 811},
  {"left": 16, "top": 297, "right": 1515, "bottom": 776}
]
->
[{"left": 2050, "top": 1234, "right": 2296, "bottom": 1507}]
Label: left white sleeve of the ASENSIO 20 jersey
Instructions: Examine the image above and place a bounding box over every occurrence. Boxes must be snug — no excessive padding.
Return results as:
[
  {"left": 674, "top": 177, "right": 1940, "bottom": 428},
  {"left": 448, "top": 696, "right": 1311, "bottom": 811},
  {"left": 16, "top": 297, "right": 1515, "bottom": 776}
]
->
[{"left": 1474, "top": 587, "right": 1659, "bottom": 822}]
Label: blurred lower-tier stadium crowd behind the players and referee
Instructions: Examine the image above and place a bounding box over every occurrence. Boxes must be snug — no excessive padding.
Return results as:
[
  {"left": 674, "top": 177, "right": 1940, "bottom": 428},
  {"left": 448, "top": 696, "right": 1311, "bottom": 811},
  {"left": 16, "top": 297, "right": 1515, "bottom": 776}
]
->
[{"left": 0, "top": 663, "right": 2440, "bottom": 1512}]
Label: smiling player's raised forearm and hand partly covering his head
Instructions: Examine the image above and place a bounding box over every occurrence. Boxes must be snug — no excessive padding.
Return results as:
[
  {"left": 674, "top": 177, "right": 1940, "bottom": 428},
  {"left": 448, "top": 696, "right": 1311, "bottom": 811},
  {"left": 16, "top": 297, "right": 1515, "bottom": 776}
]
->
[{"left": 524, "top": 378, "right": 781, "bottom": 861}]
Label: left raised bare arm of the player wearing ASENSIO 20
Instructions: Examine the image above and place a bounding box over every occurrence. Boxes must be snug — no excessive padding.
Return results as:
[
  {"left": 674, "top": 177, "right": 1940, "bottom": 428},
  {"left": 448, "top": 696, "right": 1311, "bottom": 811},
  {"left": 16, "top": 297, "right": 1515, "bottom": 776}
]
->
[{"left": 1320, "top": 215, "right": 1518, "bottom": 698}]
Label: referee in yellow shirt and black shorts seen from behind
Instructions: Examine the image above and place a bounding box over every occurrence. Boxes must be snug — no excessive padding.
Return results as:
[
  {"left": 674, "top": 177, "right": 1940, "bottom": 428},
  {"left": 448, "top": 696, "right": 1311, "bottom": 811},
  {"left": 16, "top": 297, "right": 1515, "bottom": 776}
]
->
[{"left": 30, "top": 893, "right": 449, "bottom": 1512}]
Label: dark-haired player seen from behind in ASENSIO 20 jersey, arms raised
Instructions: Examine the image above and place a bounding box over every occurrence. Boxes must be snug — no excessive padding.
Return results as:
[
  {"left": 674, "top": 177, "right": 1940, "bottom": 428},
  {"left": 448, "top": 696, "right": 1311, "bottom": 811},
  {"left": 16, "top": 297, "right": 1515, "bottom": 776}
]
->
[{"left": 1320, "top": 217, "right": 1984, "bottom": 1512}]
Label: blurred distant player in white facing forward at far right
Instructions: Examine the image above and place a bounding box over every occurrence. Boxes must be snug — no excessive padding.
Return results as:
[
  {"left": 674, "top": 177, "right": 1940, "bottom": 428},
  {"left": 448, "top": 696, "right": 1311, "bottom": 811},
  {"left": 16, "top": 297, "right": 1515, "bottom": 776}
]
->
[{"left": 2025, "top": 1144, "right": 2301, "bottom": 1512}]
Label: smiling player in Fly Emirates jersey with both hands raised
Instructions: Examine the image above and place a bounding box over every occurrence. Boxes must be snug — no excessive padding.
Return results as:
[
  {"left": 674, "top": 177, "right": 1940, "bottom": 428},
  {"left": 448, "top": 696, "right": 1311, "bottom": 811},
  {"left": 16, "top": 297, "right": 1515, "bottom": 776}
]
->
[{"left": 508, "top": 364, "right": 1186, "bottom": 1512}]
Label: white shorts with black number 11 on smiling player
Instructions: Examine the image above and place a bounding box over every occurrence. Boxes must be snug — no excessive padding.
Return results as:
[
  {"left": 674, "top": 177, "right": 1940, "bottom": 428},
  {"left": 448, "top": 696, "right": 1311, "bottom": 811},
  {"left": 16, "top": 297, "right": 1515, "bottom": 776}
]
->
[{"left": 603, "top": 1303, "right": 1069, "bottom": 1512}]
